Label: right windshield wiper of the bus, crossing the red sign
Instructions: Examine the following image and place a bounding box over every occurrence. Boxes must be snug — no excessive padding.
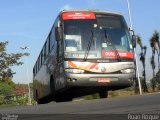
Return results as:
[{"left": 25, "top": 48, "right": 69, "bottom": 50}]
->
[{"left": 104, "top": 30, "right": 121, "bottom": 61}]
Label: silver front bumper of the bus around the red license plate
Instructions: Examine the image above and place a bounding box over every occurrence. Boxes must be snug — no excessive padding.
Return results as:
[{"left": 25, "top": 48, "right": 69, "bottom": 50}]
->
[{"left": 66, "top": 73, "right": 134, "bottom": 87}]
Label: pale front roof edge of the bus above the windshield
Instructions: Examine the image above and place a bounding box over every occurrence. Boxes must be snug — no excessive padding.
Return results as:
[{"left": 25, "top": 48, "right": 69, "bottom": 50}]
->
[{"left": 61, "top": 9, "right": 122, "bottom": 16}]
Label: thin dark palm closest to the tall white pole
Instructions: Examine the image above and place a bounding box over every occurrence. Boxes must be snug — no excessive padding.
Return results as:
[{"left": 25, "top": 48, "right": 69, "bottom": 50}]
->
[{"left": 137, "top": 35, "right": 148, "bottom": 92}]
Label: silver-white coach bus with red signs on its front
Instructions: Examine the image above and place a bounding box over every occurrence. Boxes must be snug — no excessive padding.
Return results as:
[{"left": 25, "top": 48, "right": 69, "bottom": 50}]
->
[{"left": 33, "top": 10, "right": 135, "bottom": 104}]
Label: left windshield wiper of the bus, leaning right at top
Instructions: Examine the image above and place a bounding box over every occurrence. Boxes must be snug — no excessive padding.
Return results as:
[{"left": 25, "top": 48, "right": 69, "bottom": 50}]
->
[{"left": 83, "top": 30, "right": 93, "bottom": 61}]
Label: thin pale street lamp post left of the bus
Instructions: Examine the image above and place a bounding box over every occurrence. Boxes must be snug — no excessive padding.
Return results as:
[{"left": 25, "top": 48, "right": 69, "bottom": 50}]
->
[{"left": 20, "top": 46, "right": 32, "bottom": 105}]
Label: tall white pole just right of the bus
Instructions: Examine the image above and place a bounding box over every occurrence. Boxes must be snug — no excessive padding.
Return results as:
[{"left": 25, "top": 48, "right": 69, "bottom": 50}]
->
[{"left": 127, "top": 0, "right": 142, "bottom": 95}]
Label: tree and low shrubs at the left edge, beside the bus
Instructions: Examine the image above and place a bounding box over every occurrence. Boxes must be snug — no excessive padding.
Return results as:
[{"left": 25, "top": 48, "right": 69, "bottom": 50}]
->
[{"left": 0, "top": 41, "right": 32, "bottom": 107}]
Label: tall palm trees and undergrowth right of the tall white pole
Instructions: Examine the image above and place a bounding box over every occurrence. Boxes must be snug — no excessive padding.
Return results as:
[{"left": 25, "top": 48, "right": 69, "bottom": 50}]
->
[{"left": 135, "top": 30, "right": 160, "bottom": 93}]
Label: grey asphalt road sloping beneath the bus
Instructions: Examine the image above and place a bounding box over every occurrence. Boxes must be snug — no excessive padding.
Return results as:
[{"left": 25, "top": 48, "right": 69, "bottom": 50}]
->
[{"left": 0, "top": 93, "right": 160, "bottom": 120}]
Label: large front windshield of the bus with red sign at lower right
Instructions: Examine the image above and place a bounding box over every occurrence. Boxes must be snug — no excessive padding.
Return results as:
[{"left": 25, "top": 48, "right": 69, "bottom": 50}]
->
[{"left": 64, "top": 14, "right": 132, "bottom": 59}]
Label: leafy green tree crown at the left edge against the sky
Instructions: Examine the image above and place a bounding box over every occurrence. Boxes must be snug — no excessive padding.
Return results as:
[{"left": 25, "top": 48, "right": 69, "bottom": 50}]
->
[{"left": 0, "top": 41, "right": 28, "bottom": 82}]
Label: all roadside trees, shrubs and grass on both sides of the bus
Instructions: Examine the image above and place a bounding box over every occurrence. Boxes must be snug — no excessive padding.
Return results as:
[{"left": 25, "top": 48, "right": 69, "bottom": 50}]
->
[{"left": 0, "top": 31, "right": 160, "bottom": 107}]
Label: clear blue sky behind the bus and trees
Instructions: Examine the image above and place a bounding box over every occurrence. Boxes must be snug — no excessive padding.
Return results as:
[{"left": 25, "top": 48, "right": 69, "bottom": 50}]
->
[{"left": 0, "top": 0, "right": 160, "bottom": 83}]
